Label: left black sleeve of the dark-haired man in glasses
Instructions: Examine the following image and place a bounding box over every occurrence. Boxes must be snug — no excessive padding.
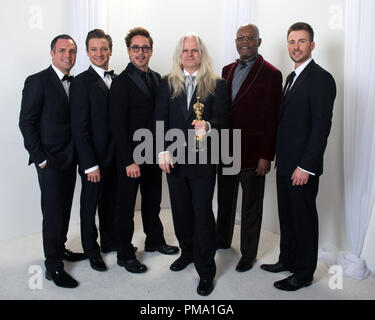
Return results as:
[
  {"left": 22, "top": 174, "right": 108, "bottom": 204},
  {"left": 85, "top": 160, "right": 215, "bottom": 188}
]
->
[{"left": 109, "top": 77, "right": 134, "bottom": 167}]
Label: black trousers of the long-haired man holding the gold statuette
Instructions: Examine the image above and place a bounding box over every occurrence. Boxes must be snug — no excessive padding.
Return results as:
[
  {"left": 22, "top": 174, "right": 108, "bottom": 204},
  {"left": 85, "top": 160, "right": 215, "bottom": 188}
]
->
[{"left": 167, "top": 170, "right": 216, "bottom": 279}]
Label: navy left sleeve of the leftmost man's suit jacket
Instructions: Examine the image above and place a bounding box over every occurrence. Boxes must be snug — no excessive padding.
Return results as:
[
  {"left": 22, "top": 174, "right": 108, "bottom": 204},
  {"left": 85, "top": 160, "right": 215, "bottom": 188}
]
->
[{"left": 19, "top": 76, "right": 49, "bottom": 164}]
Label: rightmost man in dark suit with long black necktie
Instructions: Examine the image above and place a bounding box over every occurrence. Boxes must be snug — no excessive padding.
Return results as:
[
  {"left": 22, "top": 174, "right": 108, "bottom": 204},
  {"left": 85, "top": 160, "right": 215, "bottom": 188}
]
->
[{"left": 261, "top": 22, "right": 336, "bottom": 291}]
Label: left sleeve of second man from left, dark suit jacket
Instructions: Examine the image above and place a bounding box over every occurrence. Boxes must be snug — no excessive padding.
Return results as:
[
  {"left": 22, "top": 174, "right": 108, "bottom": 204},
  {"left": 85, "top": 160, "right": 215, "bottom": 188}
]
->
[{"left": 69, "top": 78, "right": 98, "bottom": 170}]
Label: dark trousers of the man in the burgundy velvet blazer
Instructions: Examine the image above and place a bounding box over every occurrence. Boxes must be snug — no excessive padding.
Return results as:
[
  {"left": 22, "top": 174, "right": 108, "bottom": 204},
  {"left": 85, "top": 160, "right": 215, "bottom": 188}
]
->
[{"left": 216, "top": 169, "right": 265, "bottom": 259}]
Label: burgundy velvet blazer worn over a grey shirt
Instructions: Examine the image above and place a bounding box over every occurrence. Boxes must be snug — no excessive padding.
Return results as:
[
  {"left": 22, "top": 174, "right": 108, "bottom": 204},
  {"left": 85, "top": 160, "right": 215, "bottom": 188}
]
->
[{"left": 222, "top": 55, "right": 282, "bottom": 170}]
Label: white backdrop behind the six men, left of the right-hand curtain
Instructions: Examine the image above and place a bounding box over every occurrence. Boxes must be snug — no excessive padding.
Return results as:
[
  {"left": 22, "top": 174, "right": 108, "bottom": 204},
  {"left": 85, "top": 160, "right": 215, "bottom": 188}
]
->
[{"left": 0, "top": 0, "right": 375, "bottom": 276}]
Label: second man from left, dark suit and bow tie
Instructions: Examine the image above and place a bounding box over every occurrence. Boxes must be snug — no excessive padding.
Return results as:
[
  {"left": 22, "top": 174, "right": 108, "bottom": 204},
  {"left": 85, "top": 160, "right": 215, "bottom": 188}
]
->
[{"left": 70, "top": 29, "right": 116, "bottom": 271}]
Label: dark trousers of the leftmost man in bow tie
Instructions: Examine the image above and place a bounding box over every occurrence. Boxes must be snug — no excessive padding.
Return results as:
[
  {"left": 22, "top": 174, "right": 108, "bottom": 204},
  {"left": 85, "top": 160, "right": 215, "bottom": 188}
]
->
[{"left": 35, "top": 163, "right": 77, "bottom": 272}]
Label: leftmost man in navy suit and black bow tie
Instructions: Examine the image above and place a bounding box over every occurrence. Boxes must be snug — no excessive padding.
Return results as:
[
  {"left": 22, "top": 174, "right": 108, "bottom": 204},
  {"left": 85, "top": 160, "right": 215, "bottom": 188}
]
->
[{"left": 19, "top": 35, "right": 85, "bottom": 288}]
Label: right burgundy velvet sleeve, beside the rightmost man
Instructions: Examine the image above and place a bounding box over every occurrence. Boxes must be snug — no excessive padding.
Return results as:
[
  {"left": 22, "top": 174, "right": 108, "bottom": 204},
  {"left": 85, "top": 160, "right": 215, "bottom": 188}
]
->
[{"left": 257, "top": 71, "right": 282, "bottom": 161}]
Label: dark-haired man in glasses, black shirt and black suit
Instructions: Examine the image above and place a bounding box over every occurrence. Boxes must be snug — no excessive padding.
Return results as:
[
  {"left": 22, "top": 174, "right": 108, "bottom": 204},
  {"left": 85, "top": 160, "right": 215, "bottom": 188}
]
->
[{"left": 109, "top": 28, "right": 178, "bottom": 273}]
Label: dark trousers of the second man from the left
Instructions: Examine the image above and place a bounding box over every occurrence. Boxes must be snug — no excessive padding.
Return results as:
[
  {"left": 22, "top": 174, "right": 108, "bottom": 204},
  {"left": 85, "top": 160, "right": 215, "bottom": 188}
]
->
[{"left": 79, "top": 165, "right": 117, "bottom": 257}]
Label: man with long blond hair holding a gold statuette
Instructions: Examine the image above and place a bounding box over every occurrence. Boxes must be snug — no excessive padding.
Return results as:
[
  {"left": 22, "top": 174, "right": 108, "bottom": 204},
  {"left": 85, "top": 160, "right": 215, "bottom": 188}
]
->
[{"left": 155, "top": 33, "right": 229, "bottom": 296}]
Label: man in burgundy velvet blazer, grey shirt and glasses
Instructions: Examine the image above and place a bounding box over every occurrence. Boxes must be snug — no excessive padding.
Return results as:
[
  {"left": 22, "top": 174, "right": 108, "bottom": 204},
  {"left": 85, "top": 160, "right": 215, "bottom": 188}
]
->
[{"left": 216, "top": 24, "right": 282, "bottom": 272}]
